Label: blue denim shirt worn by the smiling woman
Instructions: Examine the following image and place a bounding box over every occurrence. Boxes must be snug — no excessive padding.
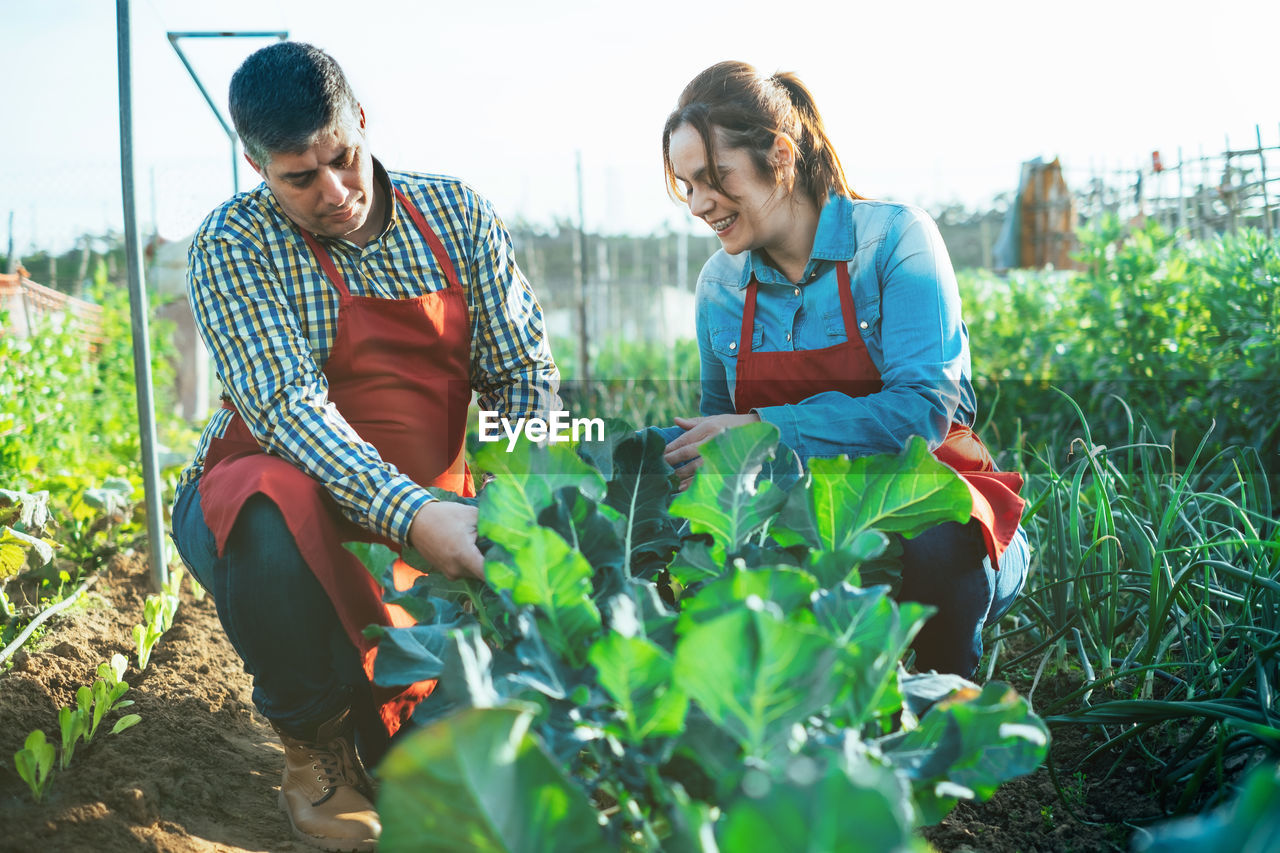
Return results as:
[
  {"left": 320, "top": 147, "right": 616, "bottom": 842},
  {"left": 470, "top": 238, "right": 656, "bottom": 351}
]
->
[{"left": 698, "top": 195, "right": 975, "bottom": 461}]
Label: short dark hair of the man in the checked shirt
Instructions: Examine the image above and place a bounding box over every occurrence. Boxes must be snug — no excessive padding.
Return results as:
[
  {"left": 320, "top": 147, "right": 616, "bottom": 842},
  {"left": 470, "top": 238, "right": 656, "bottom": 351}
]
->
[{"left": 229, "top": 41, "right": 360, "bottom": 168}]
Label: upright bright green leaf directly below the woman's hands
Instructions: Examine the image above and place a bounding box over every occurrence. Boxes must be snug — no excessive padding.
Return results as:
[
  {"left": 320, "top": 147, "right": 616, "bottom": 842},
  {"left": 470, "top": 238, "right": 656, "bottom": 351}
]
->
[{"left": 671, "top": 421, "right": 787, "bottom": 562}]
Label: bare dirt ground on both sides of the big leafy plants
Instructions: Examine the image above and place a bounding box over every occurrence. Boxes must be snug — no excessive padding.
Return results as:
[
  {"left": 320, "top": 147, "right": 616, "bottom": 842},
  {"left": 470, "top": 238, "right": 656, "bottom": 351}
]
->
[{"left": 0, "top": 557, "right": 1155, "bottom": 853}]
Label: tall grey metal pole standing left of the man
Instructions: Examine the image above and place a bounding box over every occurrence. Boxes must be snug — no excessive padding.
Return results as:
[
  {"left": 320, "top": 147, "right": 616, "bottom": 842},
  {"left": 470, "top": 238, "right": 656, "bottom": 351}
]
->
[{"left": 115, "top": 0, "right": 169, "bottom": 589}]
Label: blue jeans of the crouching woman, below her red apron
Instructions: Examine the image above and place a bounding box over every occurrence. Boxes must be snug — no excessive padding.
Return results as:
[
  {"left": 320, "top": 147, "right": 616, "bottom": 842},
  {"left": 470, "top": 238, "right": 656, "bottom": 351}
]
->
[{"left": 897, "top": 520, "right": 1030, "bottom": 678}]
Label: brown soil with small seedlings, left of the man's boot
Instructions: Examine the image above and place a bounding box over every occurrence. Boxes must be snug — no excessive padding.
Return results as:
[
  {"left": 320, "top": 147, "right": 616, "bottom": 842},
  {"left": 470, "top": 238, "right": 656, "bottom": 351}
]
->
[{"left": 0, "top": 556, "right": 304, "bottom": 853}]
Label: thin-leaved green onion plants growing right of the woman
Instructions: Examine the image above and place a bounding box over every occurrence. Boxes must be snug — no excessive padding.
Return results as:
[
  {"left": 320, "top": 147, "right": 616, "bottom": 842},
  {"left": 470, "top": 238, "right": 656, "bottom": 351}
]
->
[{"left": 1005, "top": 391, "right": 1280, "bottom": 812}]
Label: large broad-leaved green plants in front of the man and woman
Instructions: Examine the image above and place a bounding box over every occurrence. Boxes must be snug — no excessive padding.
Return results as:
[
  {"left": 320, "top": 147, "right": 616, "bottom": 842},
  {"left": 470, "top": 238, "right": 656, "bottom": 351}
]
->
[{"left": 348, "top": 424, "right": 1048, "bottom": 850}]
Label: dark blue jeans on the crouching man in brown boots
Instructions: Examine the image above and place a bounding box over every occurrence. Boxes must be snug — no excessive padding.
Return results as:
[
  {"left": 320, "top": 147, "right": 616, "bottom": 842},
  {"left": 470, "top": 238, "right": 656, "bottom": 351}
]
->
[{"left": 173, "top": 484, "right": 387, "bottom": 766}]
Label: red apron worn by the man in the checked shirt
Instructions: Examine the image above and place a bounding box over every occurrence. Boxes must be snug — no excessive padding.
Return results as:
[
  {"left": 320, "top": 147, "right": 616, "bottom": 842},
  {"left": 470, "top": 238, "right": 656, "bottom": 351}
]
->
[{"left": 200, "top": 190, "right": 475, "bottom": 734}]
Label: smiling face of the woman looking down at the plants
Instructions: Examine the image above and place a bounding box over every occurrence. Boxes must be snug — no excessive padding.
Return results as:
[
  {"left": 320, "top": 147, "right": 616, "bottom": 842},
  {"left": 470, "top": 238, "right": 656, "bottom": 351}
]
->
[{"left": 668, "top": 124, "right": 794, "bottom": 255}]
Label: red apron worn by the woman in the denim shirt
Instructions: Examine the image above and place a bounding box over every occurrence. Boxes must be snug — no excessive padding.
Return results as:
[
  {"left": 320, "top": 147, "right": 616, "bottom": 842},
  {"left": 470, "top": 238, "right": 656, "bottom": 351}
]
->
[{"left": 733, "top": 258, "right": 1025, "bottom": 569}]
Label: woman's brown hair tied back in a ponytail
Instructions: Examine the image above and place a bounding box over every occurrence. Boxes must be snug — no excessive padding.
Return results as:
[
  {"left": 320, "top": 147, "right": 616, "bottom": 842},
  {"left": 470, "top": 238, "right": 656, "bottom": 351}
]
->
[{"left": 662, "top": 61, "right": 861, "bottom": 205}]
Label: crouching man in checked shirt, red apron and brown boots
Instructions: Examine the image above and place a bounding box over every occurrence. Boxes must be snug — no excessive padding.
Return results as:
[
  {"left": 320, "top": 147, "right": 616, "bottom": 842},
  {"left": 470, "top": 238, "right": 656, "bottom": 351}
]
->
[{"left": 173, "top": 42, "right": 559, "bottom": 850}]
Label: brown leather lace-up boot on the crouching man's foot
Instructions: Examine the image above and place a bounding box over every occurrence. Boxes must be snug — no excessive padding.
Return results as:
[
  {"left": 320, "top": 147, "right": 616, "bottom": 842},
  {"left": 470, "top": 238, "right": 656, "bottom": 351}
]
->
[{"left": 275, "top": 710, "right": 383, "bottom": 850}]
